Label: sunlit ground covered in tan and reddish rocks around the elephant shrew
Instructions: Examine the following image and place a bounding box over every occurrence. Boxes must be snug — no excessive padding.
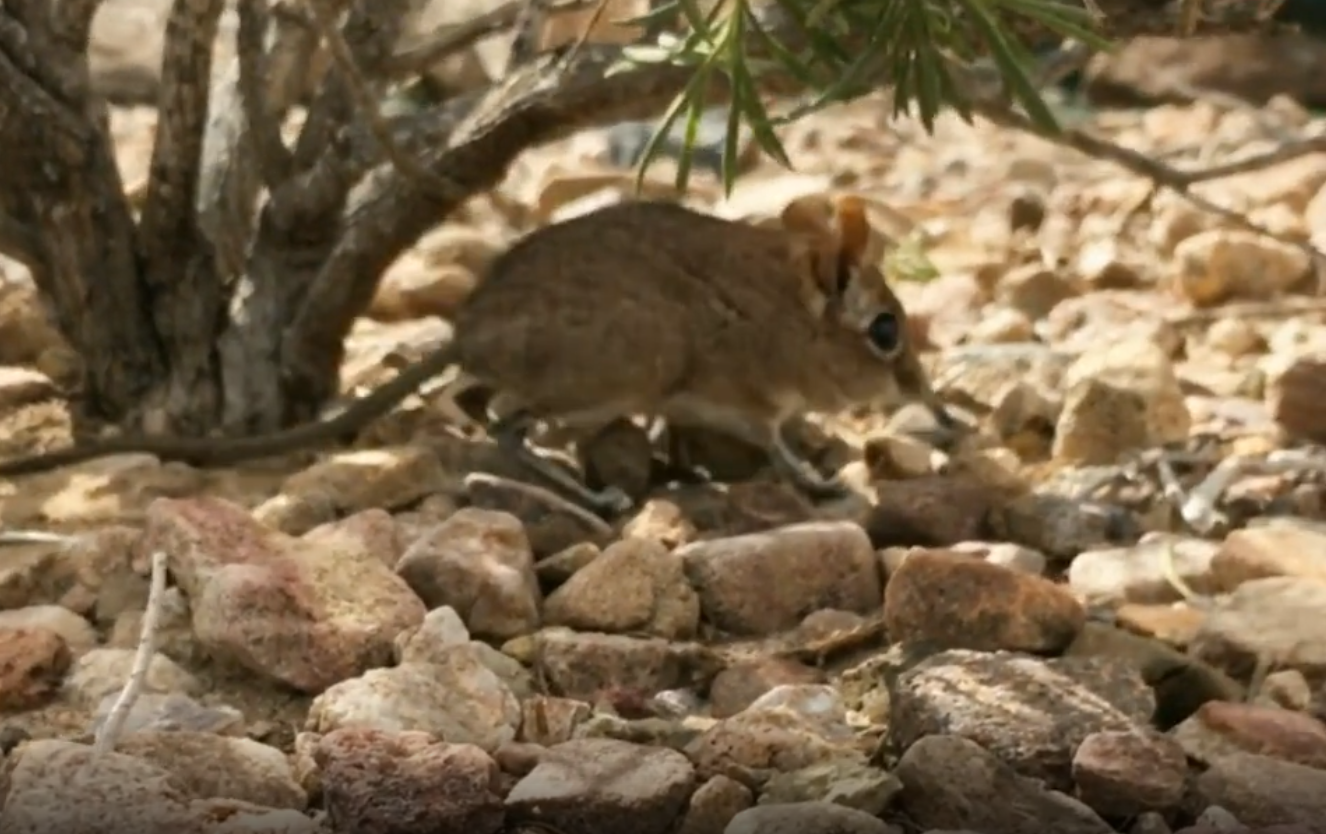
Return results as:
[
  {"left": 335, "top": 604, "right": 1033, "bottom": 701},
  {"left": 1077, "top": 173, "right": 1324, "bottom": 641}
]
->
[{"left": 0, "top": 1, "right": 1326, "bottom": 834}]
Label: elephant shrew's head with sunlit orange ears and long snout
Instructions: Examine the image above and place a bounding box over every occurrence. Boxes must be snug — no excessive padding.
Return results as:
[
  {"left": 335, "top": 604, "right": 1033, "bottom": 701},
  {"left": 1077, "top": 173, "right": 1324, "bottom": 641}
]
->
[{"left": 780, "top": 196, "right": 952, "bottom": 426}]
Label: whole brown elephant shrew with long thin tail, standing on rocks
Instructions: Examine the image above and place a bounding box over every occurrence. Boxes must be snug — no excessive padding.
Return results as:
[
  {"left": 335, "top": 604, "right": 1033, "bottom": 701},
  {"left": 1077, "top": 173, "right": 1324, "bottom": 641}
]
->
[{"left": 0, "top": 198, "right": 952, "bottom": 509}]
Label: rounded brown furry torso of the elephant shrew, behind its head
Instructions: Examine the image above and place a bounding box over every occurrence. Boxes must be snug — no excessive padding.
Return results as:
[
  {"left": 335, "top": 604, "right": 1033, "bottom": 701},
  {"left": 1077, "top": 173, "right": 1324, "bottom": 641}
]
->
[{"left": 456, "top": 202, "right": 794, "bottom": 412}]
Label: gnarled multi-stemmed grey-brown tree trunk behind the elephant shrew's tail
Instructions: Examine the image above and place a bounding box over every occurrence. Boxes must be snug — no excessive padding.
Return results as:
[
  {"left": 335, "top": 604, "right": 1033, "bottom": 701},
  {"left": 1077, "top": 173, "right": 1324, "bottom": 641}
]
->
[{"left": 0, "top": 0, "right": 1294, "bottom": 435}]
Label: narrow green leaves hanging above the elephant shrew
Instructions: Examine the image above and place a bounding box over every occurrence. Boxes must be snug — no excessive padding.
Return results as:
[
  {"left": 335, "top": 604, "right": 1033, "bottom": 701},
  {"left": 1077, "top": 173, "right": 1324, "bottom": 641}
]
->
[{"left": 615, "top": 0, "right": 1107, "bottom": 192}]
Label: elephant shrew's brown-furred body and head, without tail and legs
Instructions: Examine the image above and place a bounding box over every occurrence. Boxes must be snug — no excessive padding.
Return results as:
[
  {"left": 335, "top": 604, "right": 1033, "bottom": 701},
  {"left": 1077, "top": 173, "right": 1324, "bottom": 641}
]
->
[{"left": 456, "top": 198, "right": 932, "bottom": 426}]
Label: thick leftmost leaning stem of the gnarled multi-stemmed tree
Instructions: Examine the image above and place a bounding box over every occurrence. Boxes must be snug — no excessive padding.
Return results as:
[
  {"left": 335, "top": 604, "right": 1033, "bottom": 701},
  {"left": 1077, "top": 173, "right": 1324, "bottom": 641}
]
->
[{"left": 0, "top": 7, "right": 162, "bottom": 416}]
